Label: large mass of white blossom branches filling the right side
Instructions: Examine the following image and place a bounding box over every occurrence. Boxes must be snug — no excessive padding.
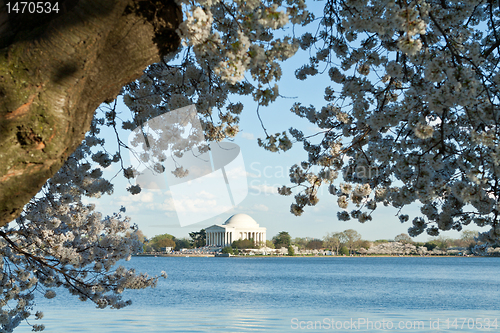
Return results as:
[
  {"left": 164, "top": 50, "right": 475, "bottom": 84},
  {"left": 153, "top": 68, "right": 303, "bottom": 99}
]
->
[{"left": 278, "top": 0, "right": 500, "bottom": 243}]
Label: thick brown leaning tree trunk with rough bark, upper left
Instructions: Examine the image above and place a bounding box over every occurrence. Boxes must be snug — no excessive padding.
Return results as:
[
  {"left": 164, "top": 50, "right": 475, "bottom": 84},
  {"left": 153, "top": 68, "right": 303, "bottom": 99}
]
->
[{"left": 0, "top": 0, "right": 182, "bottom": 226}]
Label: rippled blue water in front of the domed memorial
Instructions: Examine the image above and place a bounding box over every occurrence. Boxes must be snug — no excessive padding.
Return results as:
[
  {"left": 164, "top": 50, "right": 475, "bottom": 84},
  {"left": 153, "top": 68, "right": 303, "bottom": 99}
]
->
[{"left": 16, "top": 257, "right": 500, "bottom": 333}]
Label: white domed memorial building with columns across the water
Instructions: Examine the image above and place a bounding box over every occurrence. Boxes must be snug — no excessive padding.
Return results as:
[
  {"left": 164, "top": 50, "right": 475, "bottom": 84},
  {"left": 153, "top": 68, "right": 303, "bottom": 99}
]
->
[{"left": 205, "top": 214, "right": 266, "bottom": 247}]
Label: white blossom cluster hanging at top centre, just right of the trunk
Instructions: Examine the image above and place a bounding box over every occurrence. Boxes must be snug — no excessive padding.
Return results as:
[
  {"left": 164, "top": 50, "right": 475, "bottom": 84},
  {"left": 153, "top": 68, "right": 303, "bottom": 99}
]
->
[{"left": 124, "top": 0, "right": 313, "bottom": 141}]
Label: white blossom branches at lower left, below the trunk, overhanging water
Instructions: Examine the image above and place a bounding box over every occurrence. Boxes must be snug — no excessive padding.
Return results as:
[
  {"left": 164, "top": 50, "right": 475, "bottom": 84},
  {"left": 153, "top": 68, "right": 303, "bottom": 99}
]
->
[{"left": 0, "top": 135, "right": 166, "bottom": 332}]
